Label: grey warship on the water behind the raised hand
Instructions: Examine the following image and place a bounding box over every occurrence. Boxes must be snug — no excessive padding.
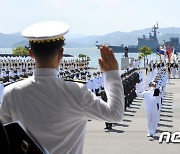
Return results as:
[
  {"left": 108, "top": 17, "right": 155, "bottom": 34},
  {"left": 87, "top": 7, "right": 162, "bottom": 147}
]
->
[{"left": 96, "top": 24, "right": 160, "bottom": 53}]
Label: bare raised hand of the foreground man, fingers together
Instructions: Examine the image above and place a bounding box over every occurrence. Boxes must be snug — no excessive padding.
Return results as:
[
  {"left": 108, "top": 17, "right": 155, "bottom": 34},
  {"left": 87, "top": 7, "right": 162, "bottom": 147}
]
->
[{"left": 98, "top": 45, "right": 119, "bottom": 73}]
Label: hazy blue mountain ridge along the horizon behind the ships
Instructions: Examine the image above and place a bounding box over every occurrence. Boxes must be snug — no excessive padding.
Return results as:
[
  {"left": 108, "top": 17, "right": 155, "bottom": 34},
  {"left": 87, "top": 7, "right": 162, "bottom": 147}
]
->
[{"left": 0, "top": 27, "right": 180, "bottom": 48}]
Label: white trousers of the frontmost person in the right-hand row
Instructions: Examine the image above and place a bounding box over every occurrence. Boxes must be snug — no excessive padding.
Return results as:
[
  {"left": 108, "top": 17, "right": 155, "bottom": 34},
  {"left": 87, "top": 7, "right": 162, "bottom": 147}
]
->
[{"left": 146, "top": 110, "right": 158, "bottom": 135}]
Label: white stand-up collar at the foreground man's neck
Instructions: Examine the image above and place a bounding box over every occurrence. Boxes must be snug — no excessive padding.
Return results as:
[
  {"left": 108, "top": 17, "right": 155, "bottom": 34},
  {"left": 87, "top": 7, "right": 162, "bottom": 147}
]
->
[{"left": 33, "top": 68, "right": 58, "bottom": 76}]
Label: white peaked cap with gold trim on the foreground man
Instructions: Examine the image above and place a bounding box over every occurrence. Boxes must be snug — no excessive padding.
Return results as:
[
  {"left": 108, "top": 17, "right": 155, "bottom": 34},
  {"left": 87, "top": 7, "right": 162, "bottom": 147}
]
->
[{"left": 21, "top": 21, "right": 69, "bottom": 42}]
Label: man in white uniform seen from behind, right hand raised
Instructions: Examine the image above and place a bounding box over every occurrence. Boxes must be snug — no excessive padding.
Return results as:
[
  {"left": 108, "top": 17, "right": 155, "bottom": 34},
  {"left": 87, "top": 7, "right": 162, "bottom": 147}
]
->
[{"left": 0, "top": 22, "right": 124, "bottom": 154}]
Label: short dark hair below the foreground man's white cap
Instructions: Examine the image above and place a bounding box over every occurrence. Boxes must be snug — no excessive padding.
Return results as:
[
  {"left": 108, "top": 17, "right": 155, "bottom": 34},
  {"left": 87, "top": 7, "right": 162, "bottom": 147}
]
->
[{"left": 29, "top": 40, "right": 64, "bottom": 61}]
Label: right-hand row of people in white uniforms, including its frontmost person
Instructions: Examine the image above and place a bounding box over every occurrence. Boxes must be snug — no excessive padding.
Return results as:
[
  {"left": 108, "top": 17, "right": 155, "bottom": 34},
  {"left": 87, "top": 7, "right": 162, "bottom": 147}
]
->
[{"left": 136, "top": 69, "right": 167, "bottom": 137}]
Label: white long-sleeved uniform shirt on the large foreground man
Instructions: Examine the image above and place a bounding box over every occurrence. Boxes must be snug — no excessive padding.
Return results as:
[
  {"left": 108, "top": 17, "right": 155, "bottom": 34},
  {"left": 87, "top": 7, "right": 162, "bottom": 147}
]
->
[{"left": 0, "top": 68, "right": 124, "bottom": 154}]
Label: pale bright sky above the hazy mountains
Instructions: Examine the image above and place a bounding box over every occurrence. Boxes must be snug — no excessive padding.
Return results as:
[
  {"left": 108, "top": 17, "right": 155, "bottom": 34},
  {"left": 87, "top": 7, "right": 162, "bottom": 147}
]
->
[{"left": 0, "top": 0, "right": 180, "bottom": 35}]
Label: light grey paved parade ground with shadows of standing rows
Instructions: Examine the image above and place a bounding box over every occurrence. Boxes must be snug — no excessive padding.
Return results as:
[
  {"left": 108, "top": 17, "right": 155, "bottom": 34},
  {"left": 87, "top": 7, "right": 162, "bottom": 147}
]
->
[{"left": 84, "top": 79, "right": 180, "bottom": 154}]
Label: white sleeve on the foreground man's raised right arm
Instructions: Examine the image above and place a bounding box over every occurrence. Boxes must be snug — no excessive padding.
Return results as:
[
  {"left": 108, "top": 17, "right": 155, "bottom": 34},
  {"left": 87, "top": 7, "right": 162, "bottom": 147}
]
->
[{"left": 82, "top": 70, "right": 124, "bottom": 122}]
